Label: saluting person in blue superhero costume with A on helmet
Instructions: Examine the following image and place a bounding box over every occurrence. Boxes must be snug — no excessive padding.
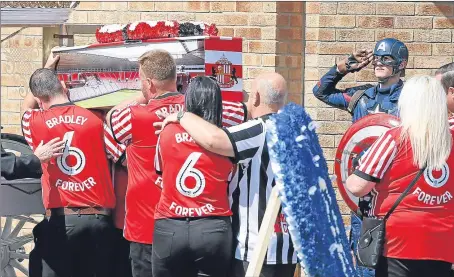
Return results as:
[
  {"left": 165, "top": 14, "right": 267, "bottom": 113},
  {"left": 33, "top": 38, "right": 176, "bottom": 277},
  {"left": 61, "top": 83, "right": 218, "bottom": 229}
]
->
[{"left": 313, "top": 38, "right": 408, "bottom": 277}]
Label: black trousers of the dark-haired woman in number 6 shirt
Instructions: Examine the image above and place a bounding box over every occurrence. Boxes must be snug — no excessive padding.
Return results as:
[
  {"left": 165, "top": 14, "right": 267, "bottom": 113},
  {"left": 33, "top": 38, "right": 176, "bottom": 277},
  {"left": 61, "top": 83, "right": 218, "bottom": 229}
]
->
[{"left": 153, "top": 217, "right": 232, "bottom": 277}]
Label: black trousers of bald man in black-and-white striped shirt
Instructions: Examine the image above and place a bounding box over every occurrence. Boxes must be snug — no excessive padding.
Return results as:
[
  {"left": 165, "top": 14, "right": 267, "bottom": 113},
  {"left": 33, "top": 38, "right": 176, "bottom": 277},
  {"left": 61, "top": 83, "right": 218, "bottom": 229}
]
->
[{"left": 229, "top": 259, "right": 296, "bottom": 277}]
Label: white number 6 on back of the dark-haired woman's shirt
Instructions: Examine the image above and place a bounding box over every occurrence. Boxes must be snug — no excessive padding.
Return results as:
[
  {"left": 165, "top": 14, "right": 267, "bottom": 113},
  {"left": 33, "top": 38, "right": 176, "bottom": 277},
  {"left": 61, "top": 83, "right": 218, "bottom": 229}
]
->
[{"left": 176, "top": 152, "right": 205, "bottom": 198}]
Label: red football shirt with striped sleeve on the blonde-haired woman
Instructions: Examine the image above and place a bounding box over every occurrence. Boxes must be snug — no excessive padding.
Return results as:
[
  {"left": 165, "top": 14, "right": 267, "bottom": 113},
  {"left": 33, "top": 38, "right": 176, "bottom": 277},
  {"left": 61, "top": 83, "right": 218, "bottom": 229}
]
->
[{"left": 354, "top": 127, "right": 454, "bottom": 263}]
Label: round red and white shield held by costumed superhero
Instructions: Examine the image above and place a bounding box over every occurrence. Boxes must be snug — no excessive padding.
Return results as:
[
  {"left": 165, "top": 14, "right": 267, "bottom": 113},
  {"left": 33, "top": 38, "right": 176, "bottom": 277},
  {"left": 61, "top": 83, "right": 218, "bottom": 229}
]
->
[{"left": 334, "top": 114, "right": 399, "bottom": 212}]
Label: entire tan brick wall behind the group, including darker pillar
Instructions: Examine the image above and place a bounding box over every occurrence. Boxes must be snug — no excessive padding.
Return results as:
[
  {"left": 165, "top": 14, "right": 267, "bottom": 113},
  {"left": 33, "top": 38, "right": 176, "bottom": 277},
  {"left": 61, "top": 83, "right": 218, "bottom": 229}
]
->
[{"left": 1, "top": 2, "right": 454, "bottom": 276}]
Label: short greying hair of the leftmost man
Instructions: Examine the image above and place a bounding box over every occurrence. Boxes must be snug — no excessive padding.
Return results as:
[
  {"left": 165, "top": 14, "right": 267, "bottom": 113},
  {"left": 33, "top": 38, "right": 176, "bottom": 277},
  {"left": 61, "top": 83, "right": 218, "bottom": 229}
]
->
[{"left": 28, "top": 68, "right": 63, "bottom": 101}]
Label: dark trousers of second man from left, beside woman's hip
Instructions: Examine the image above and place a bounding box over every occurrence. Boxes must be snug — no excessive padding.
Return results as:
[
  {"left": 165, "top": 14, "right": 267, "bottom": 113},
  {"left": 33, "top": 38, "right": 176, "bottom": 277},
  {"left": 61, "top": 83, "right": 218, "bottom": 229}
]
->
[{"left": 129, "top": 242, "right": 153, "bottom": 277}]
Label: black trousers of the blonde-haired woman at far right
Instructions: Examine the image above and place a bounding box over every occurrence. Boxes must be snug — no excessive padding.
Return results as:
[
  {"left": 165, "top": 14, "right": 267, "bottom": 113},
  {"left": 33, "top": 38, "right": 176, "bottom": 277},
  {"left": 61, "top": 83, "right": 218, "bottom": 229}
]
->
[{"left": 375, "top": 254, "right": 452, "bottom": 277}]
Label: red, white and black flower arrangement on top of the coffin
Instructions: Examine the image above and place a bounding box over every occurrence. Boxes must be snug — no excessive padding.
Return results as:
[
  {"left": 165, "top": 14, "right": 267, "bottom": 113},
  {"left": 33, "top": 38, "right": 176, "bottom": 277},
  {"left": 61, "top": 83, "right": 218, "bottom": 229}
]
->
[{"left": 96, "top": 21, "right": 218, "bottom": 43}]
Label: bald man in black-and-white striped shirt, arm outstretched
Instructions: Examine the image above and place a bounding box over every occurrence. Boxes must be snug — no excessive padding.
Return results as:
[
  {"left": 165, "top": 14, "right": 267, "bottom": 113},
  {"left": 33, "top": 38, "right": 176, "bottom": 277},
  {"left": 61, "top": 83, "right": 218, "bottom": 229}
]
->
[{"left": 155, "top": 73, "right": 297, "bottom": 277}]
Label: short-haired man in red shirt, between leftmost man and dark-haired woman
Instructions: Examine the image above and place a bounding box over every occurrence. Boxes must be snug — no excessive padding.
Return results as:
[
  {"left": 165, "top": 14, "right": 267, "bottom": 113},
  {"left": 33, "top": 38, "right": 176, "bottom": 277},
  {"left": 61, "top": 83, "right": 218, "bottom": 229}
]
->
[{"left": 106, "top": 50, "right": 184, "bottom": 277}]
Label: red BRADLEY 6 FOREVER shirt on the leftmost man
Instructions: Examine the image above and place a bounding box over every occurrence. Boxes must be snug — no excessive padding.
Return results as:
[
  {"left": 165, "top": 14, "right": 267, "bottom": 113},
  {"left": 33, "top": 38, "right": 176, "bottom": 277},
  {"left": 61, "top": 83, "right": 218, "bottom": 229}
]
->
[{"left": 22, "top": 102, "right": 124, "bottom": 209}]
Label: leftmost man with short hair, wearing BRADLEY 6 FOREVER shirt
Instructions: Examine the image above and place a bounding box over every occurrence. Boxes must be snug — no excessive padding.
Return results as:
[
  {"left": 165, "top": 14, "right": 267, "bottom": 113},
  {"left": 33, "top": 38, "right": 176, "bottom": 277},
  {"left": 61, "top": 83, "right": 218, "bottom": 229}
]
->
[{"left": 22, "top": 68, "right": 121, "bottom": 277}]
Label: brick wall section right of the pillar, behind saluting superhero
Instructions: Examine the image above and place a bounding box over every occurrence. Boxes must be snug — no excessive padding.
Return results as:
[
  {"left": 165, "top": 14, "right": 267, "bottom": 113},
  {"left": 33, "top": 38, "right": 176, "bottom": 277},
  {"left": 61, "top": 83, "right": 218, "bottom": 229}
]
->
[{"left": 303, "top": 2, "right": 454, "bottom": 223}]
